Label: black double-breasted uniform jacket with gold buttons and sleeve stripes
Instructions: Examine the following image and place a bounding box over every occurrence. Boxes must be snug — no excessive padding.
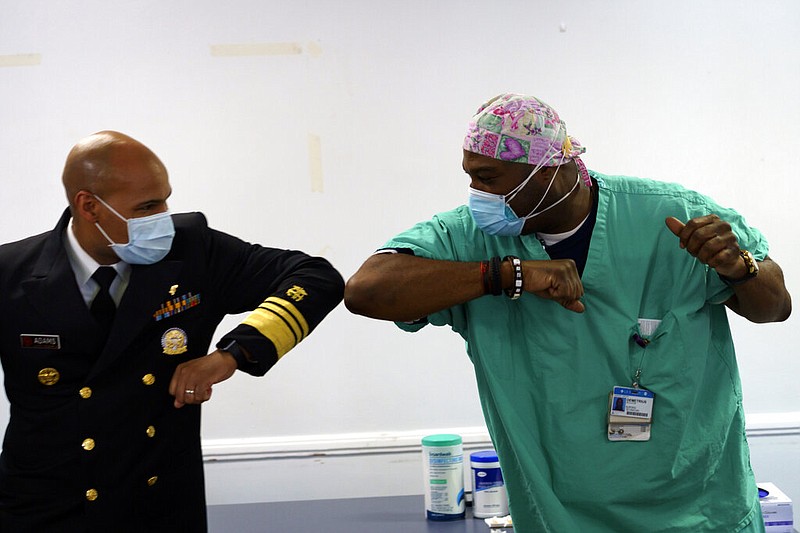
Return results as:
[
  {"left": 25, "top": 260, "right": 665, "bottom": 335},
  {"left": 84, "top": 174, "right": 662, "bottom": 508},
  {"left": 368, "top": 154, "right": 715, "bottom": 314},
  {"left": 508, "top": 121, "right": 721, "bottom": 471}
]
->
[{"left": 0, "top": 211, "right": 343, "bottom": 533}]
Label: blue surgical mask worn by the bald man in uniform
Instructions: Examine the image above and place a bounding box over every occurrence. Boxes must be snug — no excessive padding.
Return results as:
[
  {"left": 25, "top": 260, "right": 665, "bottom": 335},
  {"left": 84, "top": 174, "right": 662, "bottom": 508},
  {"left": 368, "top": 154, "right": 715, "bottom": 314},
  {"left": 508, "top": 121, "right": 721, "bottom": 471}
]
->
[{"left": 94, "top": 195, "right": 175, "bottom": 265}]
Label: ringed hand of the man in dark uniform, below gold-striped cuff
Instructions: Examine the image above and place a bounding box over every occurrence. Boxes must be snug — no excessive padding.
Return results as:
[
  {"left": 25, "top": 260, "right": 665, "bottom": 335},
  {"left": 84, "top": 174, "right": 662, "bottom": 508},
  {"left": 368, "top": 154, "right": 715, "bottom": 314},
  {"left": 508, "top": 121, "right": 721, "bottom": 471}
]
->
[{"left": 169, "top": 350, "right": 236, "bottom": 408}]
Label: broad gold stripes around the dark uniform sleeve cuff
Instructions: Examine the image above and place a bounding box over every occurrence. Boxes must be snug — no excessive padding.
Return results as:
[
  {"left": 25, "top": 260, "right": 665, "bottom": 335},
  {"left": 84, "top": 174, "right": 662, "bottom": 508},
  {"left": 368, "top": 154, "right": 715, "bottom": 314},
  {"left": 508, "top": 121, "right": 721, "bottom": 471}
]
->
[{"left": 242, "top": 296, "right": 308, "bottom": 358}]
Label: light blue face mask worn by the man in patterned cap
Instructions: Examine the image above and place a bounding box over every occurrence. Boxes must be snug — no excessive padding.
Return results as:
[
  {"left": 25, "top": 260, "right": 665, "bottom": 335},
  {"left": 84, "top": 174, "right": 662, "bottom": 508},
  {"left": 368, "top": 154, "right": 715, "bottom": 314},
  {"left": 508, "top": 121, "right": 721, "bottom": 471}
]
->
[{"left": 469, "top": 148, "right": 581, "bottom": 237}]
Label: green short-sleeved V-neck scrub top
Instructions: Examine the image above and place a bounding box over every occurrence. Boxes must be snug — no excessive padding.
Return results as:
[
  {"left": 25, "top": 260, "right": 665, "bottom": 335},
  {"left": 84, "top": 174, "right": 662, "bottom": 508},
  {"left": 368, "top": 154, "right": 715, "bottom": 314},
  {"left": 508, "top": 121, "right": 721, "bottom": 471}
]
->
[{"left": 385, "top": 172, "right": 768, "bottom": 533}]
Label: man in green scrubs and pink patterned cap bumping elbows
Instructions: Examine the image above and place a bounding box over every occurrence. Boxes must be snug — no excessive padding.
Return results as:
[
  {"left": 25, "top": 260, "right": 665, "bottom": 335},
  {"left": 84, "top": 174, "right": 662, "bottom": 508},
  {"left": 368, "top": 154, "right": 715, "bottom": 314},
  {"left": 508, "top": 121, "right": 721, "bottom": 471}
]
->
[{"left": 345, "top": 94, "right": 791, "bottom": 533}]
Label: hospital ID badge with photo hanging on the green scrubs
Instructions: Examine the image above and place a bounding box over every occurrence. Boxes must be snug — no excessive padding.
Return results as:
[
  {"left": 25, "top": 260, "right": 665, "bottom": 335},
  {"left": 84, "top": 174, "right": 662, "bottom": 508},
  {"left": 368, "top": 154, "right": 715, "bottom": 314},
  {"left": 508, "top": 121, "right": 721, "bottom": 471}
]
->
[{"left": 608, "top": 387, "right": 655, "bottom": 442}]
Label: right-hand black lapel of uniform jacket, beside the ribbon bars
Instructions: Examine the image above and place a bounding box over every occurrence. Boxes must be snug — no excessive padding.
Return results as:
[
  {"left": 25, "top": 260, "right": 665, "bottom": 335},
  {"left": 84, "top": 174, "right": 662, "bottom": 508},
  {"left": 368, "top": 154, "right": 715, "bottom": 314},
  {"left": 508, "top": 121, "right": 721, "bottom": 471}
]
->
[{"left": 90, "top": 261, "right": 183, "bottom": 378}]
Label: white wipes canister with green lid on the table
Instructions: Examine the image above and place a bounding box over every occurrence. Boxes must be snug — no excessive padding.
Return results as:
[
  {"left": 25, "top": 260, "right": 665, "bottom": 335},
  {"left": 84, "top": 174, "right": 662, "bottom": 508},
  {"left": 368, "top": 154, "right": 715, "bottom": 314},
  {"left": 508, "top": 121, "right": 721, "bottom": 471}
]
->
[{"left": 422, "top": 434, "right": 466, "bottom": 520}]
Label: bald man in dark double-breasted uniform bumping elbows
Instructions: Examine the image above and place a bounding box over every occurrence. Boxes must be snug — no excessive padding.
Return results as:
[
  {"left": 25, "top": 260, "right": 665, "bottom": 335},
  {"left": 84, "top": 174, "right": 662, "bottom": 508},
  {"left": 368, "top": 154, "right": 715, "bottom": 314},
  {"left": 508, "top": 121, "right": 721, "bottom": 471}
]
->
[{"left": 0, "top": 131, "right": 343, "bottom": 533}]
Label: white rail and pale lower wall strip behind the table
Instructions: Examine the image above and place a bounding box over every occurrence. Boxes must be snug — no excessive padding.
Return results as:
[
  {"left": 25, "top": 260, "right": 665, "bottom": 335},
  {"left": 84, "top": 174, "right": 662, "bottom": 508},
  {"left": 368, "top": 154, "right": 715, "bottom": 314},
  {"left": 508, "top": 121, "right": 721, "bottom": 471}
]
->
[{"left": 203, "top": 412, "right": 800, "bottom": 505}]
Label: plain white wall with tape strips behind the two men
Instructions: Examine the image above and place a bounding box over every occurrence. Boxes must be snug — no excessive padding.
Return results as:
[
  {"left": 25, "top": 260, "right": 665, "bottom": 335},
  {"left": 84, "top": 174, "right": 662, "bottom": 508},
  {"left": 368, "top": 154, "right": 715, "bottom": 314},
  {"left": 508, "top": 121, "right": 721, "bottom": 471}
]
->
[{"left": 0, "top": 0, "right": 800, "bottom": 516}]
